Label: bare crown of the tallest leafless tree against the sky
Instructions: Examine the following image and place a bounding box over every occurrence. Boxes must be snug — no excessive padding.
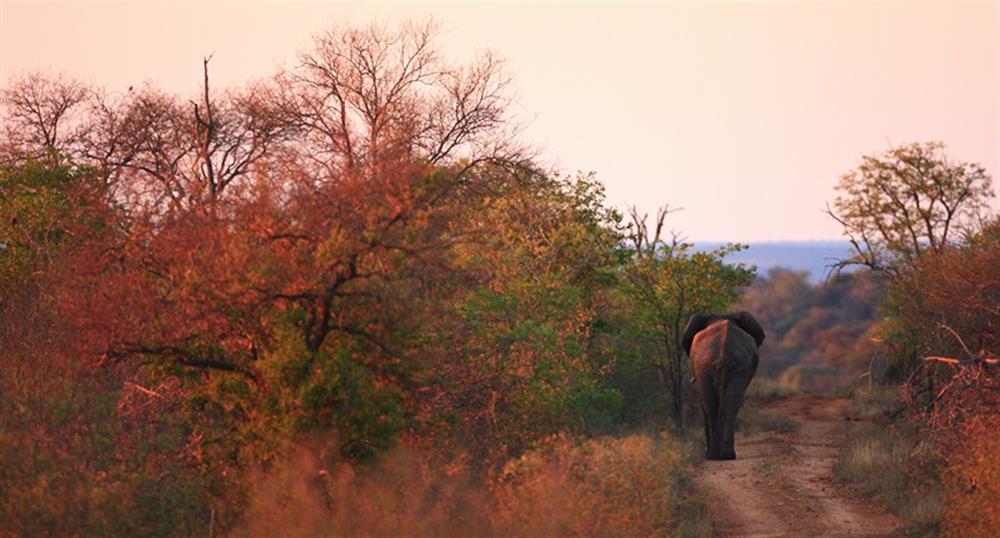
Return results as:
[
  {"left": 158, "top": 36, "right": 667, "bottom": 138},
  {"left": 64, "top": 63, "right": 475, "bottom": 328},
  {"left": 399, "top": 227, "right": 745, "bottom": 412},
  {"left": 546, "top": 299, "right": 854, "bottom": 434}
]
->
[{"left": 274, "top": 19, "right": 517, "bottom": 180}]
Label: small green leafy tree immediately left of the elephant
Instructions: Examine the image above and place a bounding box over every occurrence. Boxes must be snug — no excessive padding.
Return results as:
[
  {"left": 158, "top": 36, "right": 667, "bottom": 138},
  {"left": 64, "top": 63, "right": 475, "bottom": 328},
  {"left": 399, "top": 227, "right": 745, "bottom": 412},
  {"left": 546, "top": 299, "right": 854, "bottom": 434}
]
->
[{"left": 602, "top": 228, "right": 756, "bottom": 425}]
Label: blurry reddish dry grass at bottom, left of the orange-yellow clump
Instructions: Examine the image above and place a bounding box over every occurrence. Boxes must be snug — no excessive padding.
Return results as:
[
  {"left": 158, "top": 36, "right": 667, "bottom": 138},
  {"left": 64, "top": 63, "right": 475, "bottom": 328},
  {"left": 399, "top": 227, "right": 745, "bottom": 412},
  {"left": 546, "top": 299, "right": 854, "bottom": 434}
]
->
[{"left": 233, "top": 443, "right": 489, "bottom": 536}]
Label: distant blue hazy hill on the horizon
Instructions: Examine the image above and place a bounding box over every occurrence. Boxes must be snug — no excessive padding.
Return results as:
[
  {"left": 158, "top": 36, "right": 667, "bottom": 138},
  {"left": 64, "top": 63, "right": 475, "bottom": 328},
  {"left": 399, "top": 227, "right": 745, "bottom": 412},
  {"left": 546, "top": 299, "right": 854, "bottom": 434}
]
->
[{"left": 695, "top": 241, "right": 851, "bottom": 283}]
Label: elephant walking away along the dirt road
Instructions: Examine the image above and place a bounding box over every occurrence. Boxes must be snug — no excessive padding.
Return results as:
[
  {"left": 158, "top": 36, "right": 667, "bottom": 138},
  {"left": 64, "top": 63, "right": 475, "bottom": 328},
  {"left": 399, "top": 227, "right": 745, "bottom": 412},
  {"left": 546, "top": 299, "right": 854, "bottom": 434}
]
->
[{"left": 681, "top": 311, "right": 764, "bottom": 460}]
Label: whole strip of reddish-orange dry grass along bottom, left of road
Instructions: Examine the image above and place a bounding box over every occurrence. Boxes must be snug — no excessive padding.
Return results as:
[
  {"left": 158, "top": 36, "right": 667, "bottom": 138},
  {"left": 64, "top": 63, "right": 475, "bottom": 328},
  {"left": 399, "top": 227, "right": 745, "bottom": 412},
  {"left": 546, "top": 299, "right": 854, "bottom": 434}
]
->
[{"left": 234, "top": 435, "right": 712, "bottom": 536}]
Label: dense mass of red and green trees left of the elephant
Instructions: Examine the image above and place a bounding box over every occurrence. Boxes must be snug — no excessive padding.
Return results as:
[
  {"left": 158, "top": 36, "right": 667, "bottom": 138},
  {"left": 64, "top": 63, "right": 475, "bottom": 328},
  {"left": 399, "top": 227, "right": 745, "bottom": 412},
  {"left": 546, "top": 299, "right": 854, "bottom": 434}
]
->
[{"left": 0, "top": 21, "right": 753, "bottom": 535}]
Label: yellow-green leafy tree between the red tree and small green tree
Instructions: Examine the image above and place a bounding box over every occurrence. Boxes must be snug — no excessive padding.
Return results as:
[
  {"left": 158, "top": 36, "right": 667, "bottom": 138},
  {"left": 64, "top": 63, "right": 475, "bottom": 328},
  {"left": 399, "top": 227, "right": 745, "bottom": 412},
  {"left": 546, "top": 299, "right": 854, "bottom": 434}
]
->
[{"left": 448, "top": 176, "right": 621, "bottom": 455}]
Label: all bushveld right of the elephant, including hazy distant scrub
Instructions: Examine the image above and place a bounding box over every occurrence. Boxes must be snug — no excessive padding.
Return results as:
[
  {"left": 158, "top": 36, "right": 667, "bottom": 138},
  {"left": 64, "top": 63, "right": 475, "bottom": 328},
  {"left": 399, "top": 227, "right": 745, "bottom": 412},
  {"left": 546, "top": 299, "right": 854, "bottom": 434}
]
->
[{"left": 756, "top": 152, "right": 1000, "bottom": 536}]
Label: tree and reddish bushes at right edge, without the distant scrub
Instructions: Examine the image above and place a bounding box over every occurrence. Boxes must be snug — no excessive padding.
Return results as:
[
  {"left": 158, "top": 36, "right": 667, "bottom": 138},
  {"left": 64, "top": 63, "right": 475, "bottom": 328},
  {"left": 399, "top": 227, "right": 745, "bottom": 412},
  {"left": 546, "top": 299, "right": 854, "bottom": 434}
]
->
[{"left": 831, "top": 143, "right": 1000, "bottom": 536}]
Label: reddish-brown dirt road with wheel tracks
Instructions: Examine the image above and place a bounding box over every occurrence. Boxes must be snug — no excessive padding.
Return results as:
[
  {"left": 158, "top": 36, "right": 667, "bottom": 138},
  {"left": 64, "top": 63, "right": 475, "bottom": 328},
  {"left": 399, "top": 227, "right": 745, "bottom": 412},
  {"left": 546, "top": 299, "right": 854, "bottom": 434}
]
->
[{"left": 695, "top": 396, "right": 900, "bottom": 537}]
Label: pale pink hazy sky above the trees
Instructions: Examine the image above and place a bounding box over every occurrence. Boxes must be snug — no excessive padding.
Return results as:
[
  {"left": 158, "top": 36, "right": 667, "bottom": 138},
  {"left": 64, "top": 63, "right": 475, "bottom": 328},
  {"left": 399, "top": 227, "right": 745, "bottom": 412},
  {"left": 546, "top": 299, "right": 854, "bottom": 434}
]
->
[{"left": 0, "top": 0, "right": 1000, "bottom": 241}]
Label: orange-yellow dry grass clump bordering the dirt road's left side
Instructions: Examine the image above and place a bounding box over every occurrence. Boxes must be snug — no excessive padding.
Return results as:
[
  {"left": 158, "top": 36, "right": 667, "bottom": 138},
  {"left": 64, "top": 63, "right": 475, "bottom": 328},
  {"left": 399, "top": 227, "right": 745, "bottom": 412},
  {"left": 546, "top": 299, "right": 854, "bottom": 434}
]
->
[{"left": 497, "top": 435, "right": 710, "bottom": 536}]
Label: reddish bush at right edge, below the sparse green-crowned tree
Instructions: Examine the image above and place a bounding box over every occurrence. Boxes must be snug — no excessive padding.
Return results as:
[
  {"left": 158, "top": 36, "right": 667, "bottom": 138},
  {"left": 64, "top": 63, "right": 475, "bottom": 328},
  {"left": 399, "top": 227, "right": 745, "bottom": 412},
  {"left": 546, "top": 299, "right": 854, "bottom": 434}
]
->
[{"left": 898, "top": 220, "right": 1000, "bottom": 536}]
